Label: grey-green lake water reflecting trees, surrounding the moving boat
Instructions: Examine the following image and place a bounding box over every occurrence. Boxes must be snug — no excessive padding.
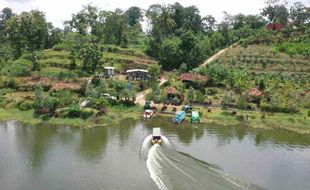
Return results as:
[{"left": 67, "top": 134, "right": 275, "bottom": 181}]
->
[{"left": 0, "top": 118, "right": 310, "bottom": 190}]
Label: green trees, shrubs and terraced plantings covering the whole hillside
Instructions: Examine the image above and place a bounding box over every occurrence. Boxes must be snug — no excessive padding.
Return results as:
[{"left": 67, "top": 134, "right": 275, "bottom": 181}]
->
[{"left": 0, "top": 0, "right": 310, "bottom": 132}]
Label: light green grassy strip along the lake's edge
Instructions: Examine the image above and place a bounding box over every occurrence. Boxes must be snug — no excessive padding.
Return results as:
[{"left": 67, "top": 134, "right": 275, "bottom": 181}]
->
[{"left": 0, "top": 106, "right": 310, "bottom": 134}]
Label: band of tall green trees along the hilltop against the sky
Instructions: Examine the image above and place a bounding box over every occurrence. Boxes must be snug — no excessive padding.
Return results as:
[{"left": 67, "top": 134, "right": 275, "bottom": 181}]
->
[{"left": 0, "top": 0, "right": 310, "bottom": 70}]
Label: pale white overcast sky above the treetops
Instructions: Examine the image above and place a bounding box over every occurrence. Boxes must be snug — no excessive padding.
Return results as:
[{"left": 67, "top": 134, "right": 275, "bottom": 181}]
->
[{"left": 0, "top": 0, "right": 309, "bottom": 28}]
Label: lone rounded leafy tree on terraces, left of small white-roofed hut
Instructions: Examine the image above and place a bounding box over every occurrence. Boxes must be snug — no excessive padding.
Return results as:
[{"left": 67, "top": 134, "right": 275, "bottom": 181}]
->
[{"left": 80, "top": 44, "right": 102, "bottom": 73}]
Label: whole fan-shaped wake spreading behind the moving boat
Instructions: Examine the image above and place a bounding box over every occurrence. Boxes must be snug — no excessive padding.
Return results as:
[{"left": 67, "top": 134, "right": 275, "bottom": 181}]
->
[{"left": 141, "top": 136, "right": 261, "bottom": 190}]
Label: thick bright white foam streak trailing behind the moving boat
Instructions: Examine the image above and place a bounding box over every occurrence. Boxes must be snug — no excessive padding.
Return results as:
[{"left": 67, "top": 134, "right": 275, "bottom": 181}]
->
[{"left": 146, "top": 144, "right": 168, "bottom": 190}]
